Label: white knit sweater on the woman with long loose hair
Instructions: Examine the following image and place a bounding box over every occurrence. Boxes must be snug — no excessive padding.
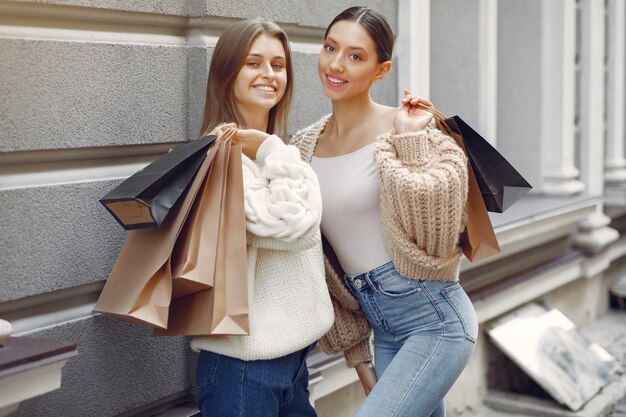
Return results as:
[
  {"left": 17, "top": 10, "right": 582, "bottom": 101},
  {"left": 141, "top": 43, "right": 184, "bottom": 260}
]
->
[{"left": 191, "top": 135, "right": 334, "bottom": 360}]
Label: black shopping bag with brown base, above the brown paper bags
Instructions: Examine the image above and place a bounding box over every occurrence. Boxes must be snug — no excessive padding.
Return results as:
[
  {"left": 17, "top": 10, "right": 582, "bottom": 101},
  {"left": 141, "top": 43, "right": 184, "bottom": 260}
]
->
[{"left": 100, "top": 135, "right": 217, "bottom": 230}]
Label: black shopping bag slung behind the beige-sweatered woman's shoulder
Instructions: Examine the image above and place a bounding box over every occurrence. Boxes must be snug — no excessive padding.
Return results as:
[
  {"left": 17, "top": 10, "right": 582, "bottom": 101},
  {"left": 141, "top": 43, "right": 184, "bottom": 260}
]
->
[{"left": 445, "top": 116, "right": 532, "bottom": 213}]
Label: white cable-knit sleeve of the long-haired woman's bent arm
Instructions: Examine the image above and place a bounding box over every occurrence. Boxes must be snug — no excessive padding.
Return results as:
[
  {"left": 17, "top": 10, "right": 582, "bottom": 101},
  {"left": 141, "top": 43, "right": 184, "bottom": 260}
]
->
[{"left": 243, "top": 135, "right": 322, "bottom": 250}]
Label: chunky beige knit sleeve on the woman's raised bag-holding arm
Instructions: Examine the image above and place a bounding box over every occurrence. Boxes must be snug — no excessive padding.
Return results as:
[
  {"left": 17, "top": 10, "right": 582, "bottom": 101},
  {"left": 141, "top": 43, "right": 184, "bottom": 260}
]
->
[{"left": 375, "top": 123, "right": 468, "bottom": 269}]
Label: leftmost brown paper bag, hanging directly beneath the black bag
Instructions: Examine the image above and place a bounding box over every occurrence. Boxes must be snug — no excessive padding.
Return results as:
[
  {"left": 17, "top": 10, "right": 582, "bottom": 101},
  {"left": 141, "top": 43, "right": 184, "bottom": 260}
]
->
[{"left": 94, "top": 142, "right": 217, "bottom": 328}]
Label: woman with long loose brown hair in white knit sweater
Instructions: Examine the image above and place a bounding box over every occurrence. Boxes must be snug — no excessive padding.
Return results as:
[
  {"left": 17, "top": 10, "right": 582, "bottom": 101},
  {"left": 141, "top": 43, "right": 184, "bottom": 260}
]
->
[{"left": 191, "top": 20, "right": 333, "bottom": 417}]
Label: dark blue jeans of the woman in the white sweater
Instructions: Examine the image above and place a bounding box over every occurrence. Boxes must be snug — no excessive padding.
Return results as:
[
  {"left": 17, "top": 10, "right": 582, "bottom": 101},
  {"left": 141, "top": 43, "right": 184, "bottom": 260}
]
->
[{"left": 196, "top": 344, "right": 316, "bottom": 417}]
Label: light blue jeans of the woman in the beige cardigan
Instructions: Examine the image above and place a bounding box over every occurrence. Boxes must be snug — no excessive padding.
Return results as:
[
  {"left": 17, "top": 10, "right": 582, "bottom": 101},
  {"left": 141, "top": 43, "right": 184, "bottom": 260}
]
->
[{"left": 345, "top": 262, "right": 478, "bottom": 417}]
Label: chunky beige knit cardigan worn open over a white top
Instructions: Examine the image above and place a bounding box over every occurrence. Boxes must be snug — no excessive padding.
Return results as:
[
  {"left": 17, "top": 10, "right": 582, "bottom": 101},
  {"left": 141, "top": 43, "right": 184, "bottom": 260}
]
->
[{"left": 290, "top": 115, "right": 468, "bottom": 366}]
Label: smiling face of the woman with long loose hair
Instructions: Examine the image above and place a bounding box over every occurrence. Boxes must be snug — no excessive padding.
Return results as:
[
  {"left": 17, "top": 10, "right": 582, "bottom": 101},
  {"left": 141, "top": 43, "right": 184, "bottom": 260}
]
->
[{"left": 233, "top": 33, "right": 288, "bottom": 113}]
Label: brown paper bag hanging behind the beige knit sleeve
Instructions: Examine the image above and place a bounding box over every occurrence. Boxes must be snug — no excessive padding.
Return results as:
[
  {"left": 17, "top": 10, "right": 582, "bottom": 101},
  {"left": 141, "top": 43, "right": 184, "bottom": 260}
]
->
[{"left": 420, "top": 106, "right": 500, "bottom": 261}]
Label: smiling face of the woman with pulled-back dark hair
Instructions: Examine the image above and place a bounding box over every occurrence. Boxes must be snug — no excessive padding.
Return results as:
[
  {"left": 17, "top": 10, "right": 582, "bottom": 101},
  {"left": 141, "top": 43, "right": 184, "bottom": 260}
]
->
[{"left": 317, "top": 20, "right": 391, "bottom": 101}]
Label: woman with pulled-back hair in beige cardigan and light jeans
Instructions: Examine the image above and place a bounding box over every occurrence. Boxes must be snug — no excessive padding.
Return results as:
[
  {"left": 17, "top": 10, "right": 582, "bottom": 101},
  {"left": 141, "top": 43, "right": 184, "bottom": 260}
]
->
[{"left": 291, "top": 7, "right": 478, "bottom": 417}]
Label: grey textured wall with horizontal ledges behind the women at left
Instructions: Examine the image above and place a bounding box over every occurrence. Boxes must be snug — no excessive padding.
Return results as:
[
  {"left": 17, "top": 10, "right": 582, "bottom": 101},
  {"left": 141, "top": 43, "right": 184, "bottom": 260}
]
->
[{"left": 0, "top": 0, "right": 397, "bottom": 417}]
